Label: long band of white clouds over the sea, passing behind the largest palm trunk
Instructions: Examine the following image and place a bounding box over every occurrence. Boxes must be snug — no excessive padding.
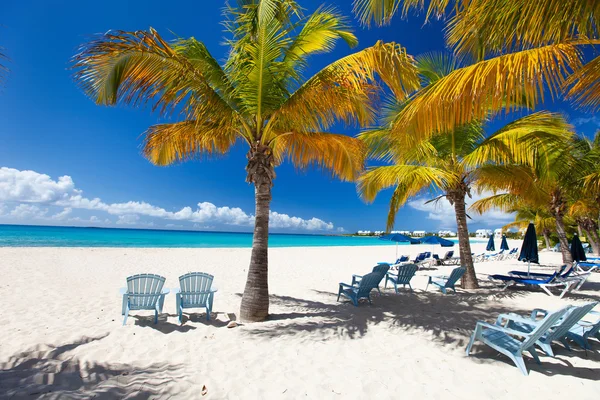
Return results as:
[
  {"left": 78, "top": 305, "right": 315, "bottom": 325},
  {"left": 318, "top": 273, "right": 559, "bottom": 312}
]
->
[{"left": 0, "top": 167, "right": 334, "bottom": 231}]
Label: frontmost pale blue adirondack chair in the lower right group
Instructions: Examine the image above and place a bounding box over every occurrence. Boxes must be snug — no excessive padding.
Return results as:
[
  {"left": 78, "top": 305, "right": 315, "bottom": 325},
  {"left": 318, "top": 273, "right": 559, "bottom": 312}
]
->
[{"left": 467, "top": 307, "right": 569, "bottom": 375}]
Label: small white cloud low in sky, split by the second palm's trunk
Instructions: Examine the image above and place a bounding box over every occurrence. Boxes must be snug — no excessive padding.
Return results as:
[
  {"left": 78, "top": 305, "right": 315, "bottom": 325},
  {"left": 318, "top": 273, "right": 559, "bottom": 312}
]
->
[{"left": 407, "top": 192, "right": 514, "bottom": 229}]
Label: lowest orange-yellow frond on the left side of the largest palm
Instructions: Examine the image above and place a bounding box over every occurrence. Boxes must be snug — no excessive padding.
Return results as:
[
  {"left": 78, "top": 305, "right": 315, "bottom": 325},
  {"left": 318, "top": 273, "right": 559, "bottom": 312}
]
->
[{"left": 143, "top": 121, "right": 239, "bottom": 165}]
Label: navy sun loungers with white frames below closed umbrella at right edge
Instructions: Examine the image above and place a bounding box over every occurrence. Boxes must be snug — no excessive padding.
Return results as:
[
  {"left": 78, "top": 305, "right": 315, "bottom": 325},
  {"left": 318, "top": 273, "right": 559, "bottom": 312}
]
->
[{"left": 489, "top": 265, "right": 591, "bottom": 298}]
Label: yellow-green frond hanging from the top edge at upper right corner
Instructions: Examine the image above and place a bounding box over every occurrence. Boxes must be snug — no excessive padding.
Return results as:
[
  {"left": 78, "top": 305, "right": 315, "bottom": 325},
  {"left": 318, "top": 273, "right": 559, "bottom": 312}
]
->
[{"left": 446, "top": 0, "right": 600, "bottom": 56}]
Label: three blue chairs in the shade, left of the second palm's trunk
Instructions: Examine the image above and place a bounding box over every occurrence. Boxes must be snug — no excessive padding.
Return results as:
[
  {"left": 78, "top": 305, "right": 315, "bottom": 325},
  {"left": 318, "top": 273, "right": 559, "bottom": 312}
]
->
[{"left": 337, "top": 264, "right": 465, "bottom": 307}]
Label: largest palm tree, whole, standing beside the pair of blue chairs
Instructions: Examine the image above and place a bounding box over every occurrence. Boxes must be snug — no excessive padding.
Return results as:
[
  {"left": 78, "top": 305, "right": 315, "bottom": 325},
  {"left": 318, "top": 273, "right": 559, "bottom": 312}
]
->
[{"left": 74, "top": 0, "right": 418, "bottom": 321}]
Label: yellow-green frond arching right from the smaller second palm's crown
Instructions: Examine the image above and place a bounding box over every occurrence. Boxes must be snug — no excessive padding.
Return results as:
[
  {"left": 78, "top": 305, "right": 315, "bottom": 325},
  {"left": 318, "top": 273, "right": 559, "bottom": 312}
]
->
[{"left": 463, "top": 111, "right": 574, "bottom": 166}]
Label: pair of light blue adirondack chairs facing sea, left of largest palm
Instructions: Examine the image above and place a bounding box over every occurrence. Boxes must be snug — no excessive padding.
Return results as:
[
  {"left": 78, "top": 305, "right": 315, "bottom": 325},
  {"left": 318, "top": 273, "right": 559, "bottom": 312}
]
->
[{"left": 121, "top": 272, "right": 217, "bottom": 325}]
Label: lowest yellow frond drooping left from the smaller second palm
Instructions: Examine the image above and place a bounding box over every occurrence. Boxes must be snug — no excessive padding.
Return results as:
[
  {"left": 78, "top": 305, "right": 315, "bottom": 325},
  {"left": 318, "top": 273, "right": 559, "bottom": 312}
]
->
[{"left": 358, "top": 165, "right": 457, "bottom": 206}]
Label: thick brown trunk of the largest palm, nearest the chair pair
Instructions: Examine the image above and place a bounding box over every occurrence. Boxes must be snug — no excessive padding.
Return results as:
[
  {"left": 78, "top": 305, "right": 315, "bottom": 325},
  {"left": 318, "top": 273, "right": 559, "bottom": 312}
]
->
[{"left": 240, "top": 143, "right": 275, "bottom": 322}]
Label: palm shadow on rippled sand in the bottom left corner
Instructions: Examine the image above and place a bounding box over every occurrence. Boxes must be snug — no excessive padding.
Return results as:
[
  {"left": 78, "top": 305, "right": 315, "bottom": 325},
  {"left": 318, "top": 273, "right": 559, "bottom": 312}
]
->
[{"left": 0, "top": 333, "right": 182, "bottom": 399}]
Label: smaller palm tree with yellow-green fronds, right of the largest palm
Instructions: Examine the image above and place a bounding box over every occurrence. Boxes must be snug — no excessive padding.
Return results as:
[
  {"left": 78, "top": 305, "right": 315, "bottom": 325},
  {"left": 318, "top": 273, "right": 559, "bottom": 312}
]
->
[{"left": 358, "top": 53, "right": 569, "bottom": 289}]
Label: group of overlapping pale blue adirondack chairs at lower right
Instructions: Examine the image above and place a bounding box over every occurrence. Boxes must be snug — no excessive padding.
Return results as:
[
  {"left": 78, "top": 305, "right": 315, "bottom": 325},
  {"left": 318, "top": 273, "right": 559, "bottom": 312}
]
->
[{"left": 466, "top": 302, "right": 600, "bottom": 375}]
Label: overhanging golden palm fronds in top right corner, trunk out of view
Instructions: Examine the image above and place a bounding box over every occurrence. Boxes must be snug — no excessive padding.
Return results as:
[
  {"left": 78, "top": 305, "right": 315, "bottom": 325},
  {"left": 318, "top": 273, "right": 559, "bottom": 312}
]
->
[{"left": 354, "top": 0, "right": 600, "bottom": 141}]
